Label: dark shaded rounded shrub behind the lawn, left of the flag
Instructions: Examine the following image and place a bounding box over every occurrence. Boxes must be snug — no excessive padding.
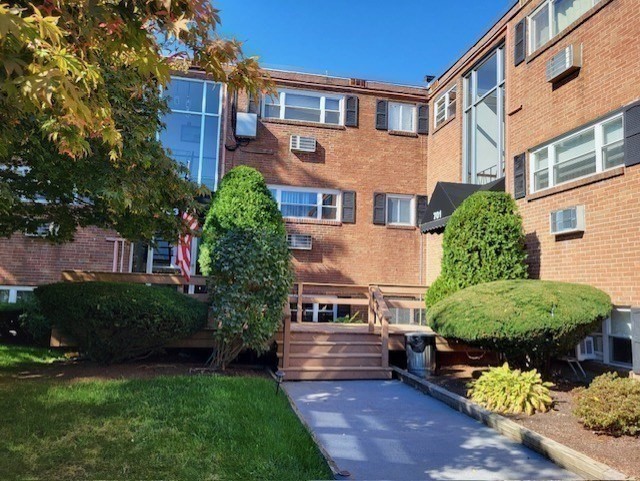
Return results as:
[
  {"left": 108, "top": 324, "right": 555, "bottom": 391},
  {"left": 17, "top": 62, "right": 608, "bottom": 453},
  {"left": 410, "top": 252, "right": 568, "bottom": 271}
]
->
[{"left": 35, "top": 282, "right": 207, "bottom": 362}]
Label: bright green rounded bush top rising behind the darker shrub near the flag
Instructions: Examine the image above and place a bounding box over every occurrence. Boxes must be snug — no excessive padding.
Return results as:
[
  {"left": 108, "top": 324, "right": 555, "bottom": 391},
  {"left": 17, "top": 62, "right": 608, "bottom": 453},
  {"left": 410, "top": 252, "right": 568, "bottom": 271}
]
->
[{"left": 198, "top": 166, "right": 286, "bottom": 275}]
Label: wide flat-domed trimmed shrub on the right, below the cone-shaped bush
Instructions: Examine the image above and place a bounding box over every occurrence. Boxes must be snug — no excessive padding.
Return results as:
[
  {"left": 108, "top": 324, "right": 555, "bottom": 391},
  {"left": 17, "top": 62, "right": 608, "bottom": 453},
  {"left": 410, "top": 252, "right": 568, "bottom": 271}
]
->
[{"left": 427, "top": 280, "right": 611, "bottom": 367}]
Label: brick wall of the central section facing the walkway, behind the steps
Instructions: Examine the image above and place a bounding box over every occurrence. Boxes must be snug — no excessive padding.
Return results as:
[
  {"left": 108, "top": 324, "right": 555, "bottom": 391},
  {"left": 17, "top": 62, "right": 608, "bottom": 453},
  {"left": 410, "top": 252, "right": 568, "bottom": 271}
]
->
[{"left": 225, "top": 75, "right": 427, "bottom": 284}]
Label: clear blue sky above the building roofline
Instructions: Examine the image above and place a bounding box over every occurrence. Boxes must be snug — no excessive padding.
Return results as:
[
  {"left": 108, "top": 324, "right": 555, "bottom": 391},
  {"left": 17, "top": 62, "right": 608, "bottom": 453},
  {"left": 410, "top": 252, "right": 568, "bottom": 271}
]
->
[{"left": 213, "top": 0, "right": 515, "bottom": 84}]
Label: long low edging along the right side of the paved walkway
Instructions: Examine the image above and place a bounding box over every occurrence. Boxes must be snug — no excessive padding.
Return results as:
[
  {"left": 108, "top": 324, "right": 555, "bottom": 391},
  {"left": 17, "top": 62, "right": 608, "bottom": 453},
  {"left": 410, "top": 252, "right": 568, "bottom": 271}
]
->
[{"left": 392, "top": 366, "right": 627, "bottom": 480}]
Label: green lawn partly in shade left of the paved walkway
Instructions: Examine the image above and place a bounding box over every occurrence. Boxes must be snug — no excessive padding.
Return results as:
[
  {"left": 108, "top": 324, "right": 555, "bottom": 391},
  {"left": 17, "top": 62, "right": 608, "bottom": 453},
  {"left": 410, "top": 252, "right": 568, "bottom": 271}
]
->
[{"left": 0, "top": 353, "right": 331, "bottom": 480}]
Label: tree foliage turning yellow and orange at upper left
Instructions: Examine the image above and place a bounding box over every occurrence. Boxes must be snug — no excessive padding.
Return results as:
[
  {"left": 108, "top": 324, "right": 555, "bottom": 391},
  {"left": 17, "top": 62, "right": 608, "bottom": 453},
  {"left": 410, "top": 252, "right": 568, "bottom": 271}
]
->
[{"left": 0, "top": 0, "right": 270, "bottom": 241}]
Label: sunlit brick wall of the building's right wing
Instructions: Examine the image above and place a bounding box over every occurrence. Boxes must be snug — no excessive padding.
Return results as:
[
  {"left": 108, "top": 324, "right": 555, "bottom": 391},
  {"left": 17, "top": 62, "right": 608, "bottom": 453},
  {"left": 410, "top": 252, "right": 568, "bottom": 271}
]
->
[{"left": 427, "top": 0, "right": 640, "bottom": 306}]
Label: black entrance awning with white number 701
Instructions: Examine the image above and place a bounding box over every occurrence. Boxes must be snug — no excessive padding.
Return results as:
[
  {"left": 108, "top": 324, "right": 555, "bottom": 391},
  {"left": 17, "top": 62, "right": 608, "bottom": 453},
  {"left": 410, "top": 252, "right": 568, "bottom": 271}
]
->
[{"left": 420, "top": 177, "right": 505, "bottom": 233}]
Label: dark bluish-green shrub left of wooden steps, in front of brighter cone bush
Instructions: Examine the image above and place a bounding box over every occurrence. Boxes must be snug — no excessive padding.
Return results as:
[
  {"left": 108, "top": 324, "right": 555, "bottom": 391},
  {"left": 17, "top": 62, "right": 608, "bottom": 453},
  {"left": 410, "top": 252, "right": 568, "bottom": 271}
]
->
[{"left": 207, "top": 228, "right": 293, "bottom": 369}]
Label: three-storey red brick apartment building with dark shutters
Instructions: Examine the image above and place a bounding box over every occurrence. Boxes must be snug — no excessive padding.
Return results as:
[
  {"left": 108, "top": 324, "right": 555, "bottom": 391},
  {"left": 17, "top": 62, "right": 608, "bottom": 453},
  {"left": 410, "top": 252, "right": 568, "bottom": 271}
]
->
[{"left": 0, "top": 0, "right": 640, "bottom": 370}]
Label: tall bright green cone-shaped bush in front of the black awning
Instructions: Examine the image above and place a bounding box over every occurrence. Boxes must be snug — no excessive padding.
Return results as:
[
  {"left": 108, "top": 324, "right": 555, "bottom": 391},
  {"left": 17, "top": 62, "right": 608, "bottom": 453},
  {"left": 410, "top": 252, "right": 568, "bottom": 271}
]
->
[{"left": 425, "top": 191, "right": 527, "bottom": 308}]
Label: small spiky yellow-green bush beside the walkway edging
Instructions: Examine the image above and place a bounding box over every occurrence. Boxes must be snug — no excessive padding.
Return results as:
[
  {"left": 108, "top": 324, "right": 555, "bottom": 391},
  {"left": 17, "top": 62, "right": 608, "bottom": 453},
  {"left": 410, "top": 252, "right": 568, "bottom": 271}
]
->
[{"left": 468, "top": 363, "right": 553, "bottom": 416}]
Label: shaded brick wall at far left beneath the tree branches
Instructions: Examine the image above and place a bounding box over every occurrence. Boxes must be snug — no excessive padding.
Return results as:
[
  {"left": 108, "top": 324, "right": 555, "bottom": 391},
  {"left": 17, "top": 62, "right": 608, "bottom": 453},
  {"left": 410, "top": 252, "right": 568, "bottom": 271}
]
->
[{"left": 0, "top": 228, "right": 129, "bottom": 286}]
